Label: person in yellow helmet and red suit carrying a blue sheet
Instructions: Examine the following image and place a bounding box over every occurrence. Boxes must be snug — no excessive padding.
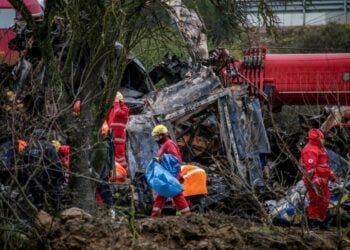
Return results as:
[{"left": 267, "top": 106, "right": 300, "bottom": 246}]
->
[{"left": 151, "top": 124, "right": 191, "bottom": 217}]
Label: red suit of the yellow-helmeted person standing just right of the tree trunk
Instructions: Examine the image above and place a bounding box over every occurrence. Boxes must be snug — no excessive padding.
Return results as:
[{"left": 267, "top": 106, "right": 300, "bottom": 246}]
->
[{"left": 106, "top": 101, "right": 129, "bottom": 169}]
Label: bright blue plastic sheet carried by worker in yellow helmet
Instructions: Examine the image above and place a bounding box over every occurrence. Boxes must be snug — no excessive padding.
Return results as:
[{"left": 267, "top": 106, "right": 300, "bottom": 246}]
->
[{"left": 146, "top": 159, "right": 184, "bottom": 198}]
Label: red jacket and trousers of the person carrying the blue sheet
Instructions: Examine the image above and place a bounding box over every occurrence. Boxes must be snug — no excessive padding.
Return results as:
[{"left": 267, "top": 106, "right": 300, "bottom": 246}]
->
[{"left": 151, "top": 137, "right": 191, "bottom": 217}]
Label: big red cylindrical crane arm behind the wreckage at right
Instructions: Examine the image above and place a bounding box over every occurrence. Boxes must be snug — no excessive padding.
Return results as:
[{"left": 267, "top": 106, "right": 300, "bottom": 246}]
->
[{"left": 218, "top": 48, "right": 350, "bottom": 107}]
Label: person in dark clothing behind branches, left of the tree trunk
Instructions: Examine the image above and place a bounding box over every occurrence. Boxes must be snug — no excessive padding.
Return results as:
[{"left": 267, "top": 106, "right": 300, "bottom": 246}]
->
[{"left": 21, "top": 129, "right": 64, "bottom": 210}]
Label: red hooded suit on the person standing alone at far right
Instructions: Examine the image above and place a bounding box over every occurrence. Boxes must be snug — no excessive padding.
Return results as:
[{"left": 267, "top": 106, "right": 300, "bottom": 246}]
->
[{"left": 301, "top": 129, "right": 336, "bottom": 220}]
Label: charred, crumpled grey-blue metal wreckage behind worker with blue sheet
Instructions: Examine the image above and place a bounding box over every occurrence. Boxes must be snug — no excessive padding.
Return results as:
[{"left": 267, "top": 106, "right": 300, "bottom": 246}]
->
[{"left": 127, "top": 67, "right": 270, "bottom": 211}]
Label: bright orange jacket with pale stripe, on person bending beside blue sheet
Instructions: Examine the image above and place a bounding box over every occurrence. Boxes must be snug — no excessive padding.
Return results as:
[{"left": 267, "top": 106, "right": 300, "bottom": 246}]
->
[{"left": 180, "top": 165, "right": 208, "bottom": 197}]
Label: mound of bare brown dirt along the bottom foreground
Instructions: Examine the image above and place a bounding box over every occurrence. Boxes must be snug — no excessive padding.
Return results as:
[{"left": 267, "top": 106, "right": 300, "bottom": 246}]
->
[{"left": 42, "top": 207, "right": 336, "bottom": 250}]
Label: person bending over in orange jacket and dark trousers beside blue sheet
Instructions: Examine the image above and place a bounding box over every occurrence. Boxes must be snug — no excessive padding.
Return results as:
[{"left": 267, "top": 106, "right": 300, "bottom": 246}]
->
[{"left": 180, "top": 165, "right": 208, "bottom": 213}]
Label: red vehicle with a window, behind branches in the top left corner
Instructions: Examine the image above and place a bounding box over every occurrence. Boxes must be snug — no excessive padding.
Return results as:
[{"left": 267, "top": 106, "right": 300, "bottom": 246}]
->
[{"left": 0, "top": 0, "right": 44, "bottom": 64}]
